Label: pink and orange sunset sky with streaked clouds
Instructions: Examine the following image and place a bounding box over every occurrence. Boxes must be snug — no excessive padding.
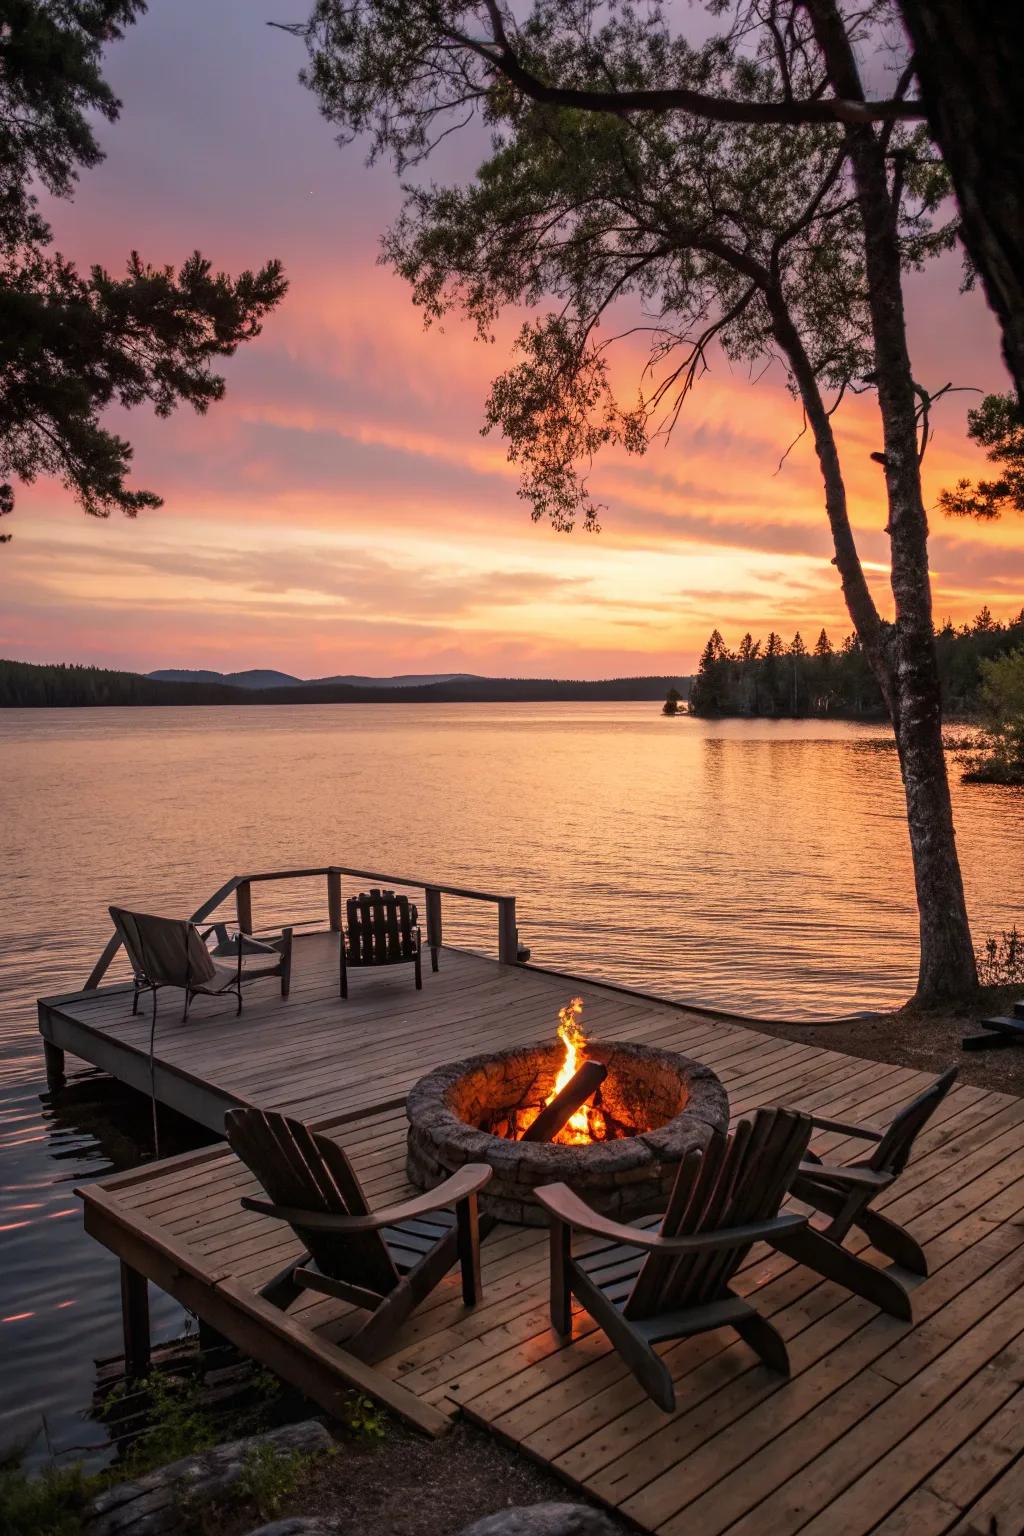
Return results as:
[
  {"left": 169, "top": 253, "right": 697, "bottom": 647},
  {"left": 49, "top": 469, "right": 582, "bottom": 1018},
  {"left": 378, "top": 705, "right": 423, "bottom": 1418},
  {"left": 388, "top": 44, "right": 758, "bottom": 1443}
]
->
[{"left": 0, "top": 0, "right": 1024, "bottom": 677}]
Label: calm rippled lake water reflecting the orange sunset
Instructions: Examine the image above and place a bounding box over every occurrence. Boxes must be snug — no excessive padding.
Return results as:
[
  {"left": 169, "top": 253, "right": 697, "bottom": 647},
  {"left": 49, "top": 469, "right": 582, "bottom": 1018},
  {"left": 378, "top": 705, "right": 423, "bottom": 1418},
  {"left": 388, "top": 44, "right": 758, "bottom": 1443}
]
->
[{"left": 0, "top": 703, "right": 1024, "bottom": 1455}]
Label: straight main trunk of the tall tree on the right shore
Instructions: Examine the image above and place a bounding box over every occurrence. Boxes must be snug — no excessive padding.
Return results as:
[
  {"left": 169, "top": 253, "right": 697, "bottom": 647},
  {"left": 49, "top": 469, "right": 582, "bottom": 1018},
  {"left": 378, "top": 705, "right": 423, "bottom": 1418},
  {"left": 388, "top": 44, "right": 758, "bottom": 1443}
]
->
[{"left": 806, "top": 0, "right": 978, "bottom": 1003}]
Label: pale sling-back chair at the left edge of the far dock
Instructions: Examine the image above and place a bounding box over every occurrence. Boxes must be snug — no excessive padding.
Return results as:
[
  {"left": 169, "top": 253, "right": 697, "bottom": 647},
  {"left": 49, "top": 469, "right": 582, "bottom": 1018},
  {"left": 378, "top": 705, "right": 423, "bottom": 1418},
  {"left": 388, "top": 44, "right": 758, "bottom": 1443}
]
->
[{"left": 109, "top": 906, "right": 292, "bottom": 1025}]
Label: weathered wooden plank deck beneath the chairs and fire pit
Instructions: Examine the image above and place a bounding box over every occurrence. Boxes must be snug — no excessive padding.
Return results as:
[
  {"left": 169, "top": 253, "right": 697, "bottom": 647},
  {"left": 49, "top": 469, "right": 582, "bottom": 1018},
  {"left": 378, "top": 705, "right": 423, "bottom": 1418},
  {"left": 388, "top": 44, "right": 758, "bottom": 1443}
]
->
[{"left": 49, "top": 935, "right": 1024, "bottom": 1536}]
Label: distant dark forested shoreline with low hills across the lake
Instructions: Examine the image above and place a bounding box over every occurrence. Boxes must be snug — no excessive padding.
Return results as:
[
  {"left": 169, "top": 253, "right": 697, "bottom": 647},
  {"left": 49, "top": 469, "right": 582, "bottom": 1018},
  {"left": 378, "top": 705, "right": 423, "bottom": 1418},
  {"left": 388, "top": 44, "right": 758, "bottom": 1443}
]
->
[{"left": 0, "top": 660, "right": 689, "bottom": 710}]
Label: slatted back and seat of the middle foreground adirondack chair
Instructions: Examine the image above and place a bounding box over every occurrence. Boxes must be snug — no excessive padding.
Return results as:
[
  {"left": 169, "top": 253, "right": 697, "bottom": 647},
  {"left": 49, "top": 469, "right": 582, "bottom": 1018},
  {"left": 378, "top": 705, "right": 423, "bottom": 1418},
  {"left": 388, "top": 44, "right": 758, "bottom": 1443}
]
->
[{"left": 625, "top": 1109, "right": 811, "bottom": 1318}]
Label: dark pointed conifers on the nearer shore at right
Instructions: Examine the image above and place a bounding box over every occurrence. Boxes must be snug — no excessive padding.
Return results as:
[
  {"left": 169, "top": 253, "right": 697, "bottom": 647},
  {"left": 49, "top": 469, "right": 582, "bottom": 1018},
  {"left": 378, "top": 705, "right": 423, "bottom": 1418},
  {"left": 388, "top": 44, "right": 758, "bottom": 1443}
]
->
[{"left": 689, "top": 607, "right": 1024, "bottom": 719}]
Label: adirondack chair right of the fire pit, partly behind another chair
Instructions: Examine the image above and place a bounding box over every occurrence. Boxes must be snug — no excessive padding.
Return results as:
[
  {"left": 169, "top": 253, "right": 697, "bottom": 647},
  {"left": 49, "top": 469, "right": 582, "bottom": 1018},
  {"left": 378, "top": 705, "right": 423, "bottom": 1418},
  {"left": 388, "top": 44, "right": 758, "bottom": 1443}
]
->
[{"left": 769, "top": 1066, "right": 958, "bottom": 1322}]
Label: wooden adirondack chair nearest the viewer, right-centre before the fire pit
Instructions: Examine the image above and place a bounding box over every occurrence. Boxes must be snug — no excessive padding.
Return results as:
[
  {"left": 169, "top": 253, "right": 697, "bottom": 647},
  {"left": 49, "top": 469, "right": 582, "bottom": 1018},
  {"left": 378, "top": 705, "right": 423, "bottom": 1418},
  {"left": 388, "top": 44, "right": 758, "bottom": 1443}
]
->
[{"left": 536, "top": 1109, "right": 811, "bottom": 1413}]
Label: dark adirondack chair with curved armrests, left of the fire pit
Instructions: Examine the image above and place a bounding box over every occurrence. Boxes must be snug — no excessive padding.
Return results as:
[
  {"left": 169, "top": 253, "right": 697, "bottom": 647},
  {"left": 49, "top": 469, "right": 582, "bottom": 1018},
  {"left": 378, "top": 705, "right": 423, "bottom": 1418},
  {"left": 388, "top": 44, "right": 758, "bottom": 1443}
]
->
[{"left": 224, "top": 1109, "right": 491, "bottom": 1359}]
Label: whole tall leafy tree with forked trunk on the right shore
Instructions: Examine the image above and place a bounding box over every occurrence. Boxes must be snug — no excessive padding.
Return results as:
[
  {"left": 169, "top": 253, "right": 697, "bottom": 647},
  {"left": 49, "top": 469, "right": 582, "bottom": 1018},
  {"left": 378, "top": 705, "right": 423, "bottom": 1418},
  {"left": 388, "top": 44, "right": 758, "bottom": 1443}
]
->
[{"left": 284, "top": 0, "right": 976, "bottom": 1001}]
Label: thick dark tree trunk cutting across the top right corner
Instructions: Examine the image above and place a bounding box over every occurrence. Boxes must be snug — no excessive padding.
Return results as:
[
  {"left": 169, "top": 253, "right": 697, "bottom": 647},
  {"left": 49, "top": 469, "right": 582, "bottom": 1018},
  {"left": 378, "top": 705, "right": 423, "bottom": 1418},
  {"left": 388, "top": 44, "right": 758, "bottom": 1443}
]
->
[{"left": 900, "top": 0, "right": 1024, "bottom": 404}]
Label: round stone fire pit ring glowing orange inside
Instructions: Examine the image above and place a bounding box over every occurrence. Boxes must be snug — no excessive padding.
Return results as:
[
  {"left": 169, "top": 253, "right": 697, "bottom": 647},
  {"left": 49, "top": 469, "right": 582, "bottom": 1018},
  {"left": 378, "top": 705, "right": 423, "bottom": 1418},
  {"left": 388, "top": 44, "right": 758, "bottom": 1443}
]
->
[{"left": 405, "top": 1040, "right": 729, "bottom": 1226}]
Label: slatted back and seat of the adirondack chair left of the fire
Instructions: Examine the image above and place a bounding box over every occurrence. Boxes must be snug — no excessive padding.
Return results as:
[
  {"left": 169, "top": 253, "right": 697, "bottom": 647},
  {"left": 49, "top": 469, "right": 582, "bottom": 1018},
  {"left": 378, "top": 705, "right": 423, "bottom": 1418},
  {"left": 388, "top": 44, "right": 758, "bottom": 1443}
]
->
[{"left": 224, "top": 1109, "right": 399, "bottom": 1296}]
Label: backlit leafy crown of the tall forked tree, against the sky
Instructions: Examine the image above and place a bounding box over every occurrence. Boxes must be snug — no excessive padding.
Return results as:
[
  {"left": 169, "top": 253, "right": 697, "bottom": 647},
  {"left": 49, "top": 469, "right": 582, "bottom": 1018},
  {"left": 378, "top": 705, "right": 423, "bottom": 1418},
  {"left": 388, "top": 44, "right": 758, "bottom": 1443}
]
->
[{"left": 292, "top": 0, "right": 953, "bottom": 531}]
